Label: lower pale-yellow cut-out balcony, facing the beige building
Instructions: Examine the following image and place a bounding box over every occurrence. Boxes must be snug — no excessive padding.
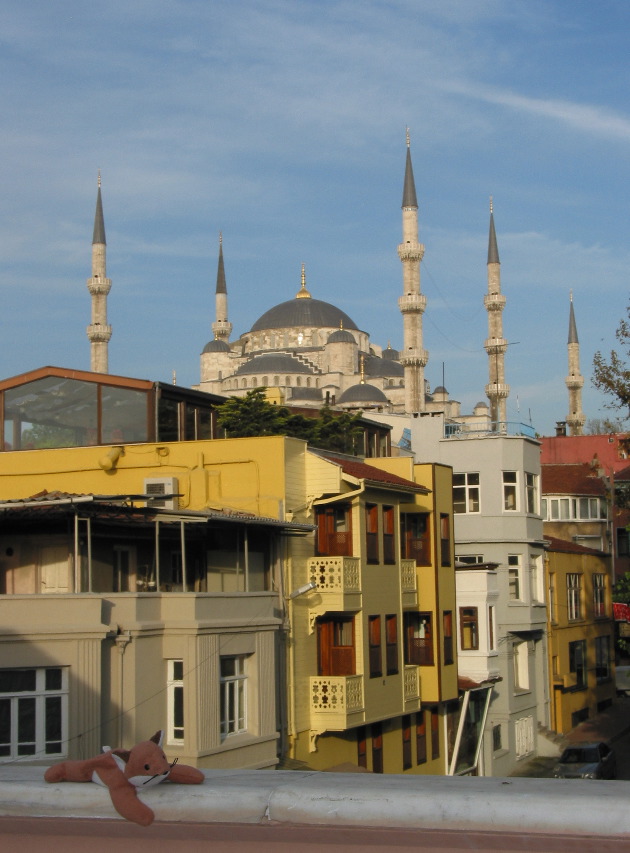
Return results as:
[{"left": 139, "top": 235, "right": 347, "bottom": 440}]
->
[{"left": 310, "top": 675, "right": 365, "bottom": 733}]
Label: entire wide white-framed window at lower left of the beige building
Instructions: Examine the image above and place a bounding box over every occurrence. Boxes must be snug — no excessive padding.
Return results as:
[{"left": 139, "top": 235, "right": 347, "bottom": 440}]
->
[{"left": 0, "top": 667, "right": 68, "bottom": 760}]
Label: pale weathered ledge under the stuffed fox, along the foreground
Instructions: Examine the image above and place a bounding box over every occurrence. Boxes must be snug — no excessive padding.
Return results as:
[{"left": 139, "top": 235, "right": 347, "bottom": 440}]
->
[{"left": 0, "top": 765, "right": 630, "bottom": 837}]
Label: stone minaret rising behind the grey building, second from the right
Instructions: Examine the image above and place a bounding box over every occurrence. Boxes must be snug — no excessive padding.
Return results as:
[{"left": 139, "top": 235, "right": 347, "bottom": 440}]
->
[{"left": 483, "top": 199, "right": 510, "bottom": 426}]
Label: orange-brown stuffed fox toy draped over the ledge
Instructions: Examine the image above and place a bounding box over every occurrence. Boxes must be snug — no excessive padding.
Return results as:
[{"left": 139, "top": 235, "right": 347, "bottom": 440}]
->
[{"left": 44, "top": 731, "right": 205, "bottom": 826}]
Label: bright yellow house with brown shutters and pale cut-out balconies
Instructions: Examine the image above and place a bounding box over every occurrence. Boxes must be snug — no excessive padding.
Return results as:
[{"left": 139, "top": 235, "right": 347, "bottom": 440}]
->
[{"left": 288, "top": 451, "right": 458, "bottom": 774}]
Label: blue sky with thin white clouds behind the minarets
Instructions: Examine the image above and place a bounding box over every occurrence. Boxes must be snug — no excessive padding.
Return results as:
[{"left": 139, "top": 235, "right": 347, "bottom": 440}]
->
[{"left": 0, "top": 0, "right": 630, "bottom": 434}]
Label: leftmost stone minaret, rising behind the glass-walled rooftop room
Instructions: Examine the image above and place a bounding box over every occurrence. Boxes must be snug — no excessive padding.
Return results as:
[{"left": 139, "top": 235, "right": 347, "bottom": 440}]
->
[{"left": 87, "top": 172, "right": 112, "bottom": 373}]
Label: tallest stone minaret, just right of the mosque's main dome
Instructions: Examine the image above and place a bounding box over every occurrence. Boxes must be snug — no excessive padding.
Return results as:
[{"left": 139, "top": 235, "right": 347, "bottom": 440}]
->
[{"left": 398, "top": 129, "right": 429, "bottom": 413}]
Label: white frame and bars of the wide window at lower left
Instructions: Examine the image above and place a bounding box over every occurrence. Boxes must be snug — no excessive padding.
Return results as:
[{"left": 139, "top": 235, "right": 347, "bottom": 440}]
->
[{"left": 0, "top": 666, "right": 68, "bottom": 763}]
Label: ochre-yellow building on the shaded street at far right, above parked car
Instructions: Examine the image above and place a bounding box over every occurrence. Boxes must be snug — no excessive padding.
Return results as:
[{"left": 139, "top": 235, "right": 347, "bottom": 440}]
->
[{"left": 545, "top": 536, "right": 615, "bottom": 733}]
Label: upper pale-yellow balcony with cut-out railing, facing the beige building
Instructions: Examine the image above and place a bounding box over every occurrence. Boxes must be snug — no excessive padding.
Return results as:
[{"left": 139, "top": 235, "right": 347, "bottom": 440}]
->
[{"left": 307, "top": 557, "right": 361, "bottom": 617}]
